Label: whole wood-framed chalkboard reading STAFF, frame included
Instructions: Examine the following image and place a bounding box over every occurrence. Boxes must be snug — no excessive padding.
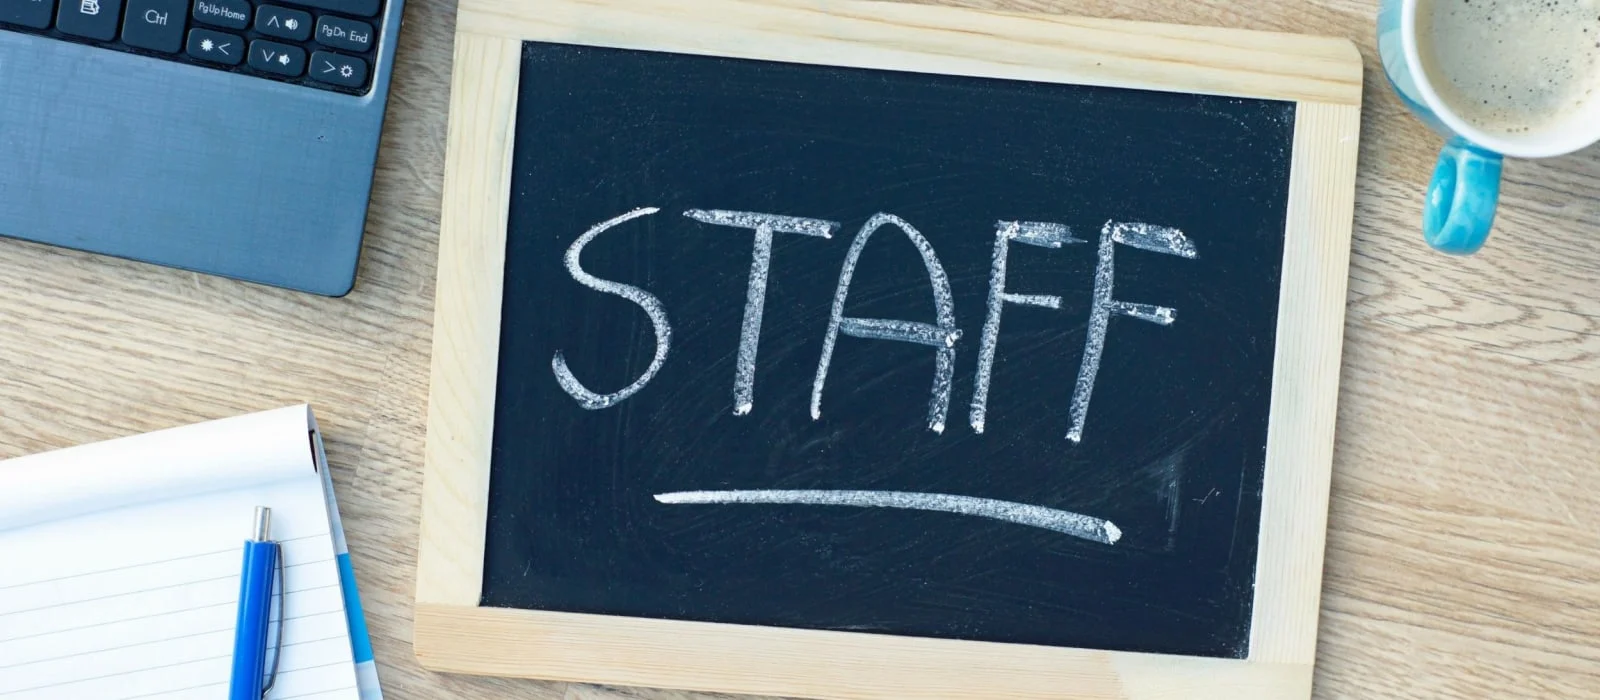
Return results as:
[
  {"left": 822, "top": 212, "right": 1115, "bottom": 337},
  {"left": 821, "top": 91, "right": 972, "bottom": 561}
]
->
[{"left": 413, "top": 0, "right": 1363, "bottom": 700}]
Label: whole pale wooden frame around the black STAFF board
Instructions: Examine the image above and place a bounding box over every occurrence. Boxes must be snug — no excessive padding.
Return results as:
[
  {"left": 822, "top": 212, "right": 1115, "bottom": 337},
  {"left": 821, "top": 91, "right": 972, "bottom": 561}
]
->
[{"left": 414, "top": 0, "right": 1362, "bottom": 700}]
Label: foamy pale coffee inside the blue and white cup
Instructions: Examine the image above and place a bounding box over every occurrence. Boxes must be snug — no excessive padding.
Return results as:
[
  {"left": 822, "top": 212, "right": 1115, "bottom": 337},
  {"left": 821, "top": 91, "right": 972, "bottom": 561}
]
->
[{"left": 1418, "top": 0, "right": 1600, "bottom": 134}]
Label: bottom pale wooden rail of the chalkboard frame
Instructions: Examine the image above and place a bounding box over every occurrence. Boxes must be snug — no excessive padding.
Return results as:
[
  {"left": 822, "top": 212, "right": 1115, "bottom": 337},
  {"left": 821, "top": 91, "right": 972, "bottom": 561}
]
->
[{"left": 416, "top": 604, "right": 1310, "bottom": 700}]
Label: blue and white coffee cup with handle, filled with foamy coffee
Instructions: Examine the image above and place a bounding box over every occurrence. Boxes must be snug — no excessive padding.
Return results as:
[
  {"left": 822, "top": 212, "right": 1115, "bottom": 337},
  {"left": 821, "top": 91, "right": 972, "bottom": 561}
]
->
[{"left": 1378, "top": 0, "right": 1600, "bottom": 254}]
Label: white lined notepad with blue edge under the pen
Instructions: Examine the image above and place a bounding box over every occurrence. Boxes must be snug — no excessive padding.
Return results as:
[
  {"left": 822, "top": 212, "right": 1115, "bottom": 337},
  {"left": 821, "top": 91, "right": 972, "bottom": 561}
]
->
[{"left": 0, "top": 406, "right": 378, "bottom": 700}]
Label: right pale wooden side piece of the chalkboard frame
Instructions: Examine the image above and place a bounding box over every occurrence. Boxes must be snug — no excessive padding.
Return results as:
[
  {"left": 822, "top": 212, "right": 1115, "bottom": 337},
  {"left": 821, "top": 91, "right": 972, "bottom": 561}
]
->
[{"left": 1250, "top": 104, "right": 1362, "bottom": 664}]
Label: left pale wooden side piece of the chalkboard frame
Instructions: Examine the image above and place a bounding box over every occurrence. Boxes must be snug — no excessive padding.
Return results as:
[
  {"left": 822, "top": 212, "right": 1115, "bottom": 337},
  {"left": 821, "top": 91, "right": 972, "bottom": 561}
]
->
[{"left": 416, "top": 32, "right": 522, "bottom": 606}]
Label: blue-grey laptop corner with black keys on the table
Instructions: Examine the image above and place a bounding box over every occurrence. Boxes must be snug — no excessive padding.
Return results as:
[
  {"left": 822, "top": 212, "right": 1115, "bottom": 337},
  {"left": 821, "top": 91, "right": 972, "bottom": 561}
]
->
[{"left": 0, "top": 0, "right": 402, "bottom": 296}]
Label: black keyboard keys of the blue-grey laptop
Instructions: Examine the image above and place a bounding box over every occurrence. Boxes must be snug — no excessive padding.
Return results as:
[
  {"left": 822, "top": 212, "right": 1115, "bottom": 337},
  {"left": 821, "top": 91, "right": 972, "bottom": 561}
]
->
[{"left": 0, "top": 0, "right": 382, "bottom": 94}]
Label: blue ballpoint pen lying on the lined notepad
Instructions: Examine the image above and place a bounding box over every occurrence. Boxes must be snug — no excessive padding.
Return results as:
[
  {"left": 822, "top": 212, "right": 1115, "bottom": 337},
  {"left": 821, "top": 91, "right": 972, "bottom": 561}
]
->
[{"left": 227, "top": 507, "right": 283, "bottom": 700}]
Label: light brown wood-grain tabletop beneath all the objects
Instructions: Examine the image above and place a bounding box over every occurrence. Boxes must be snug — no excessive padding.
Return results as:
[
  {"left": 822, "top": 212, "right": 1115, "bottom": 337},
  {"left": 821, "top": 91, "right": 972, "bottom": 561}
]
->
[{"left": 0, "top": 0, "right": 1600, "bottom": 700}]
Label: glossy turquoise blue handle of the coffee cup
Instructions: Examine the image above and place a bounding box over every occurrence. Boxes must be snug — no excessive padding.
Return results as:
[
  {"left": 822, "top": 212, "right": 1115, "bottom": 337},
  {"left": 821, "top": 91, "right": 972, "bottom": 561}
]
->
[{"left": 1422, "top": 136, "right": 1502, "bottom": 256}]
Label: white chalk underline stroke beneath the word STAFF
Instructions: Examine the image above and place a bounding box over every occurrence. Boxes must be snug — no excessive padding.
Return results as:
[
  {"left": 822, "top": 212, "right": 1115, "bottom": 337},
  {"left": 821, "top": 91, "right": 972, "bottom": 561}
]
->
[{"left": 656, "top": 491, "right": 1122, "bottom": 545}]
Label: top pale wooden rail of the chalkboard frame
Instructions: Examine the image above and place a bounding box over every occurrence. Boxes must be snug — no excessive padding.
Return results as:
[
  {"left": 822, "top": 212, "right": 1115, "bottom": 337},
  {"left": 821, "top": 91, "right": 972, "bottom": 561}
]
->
[{"left": 458, "top": 0, "right": 1362, "bottom": 104}]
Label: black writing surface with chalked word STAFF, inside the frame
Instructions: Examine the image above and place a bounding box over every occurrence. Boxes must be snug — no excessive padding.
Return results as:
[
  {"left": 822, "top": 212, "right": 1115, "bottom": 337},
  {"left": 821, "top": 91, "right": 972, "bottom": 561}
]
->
[{"left": 482, "top": 43, "right": 1296, "bottom": 657}]
